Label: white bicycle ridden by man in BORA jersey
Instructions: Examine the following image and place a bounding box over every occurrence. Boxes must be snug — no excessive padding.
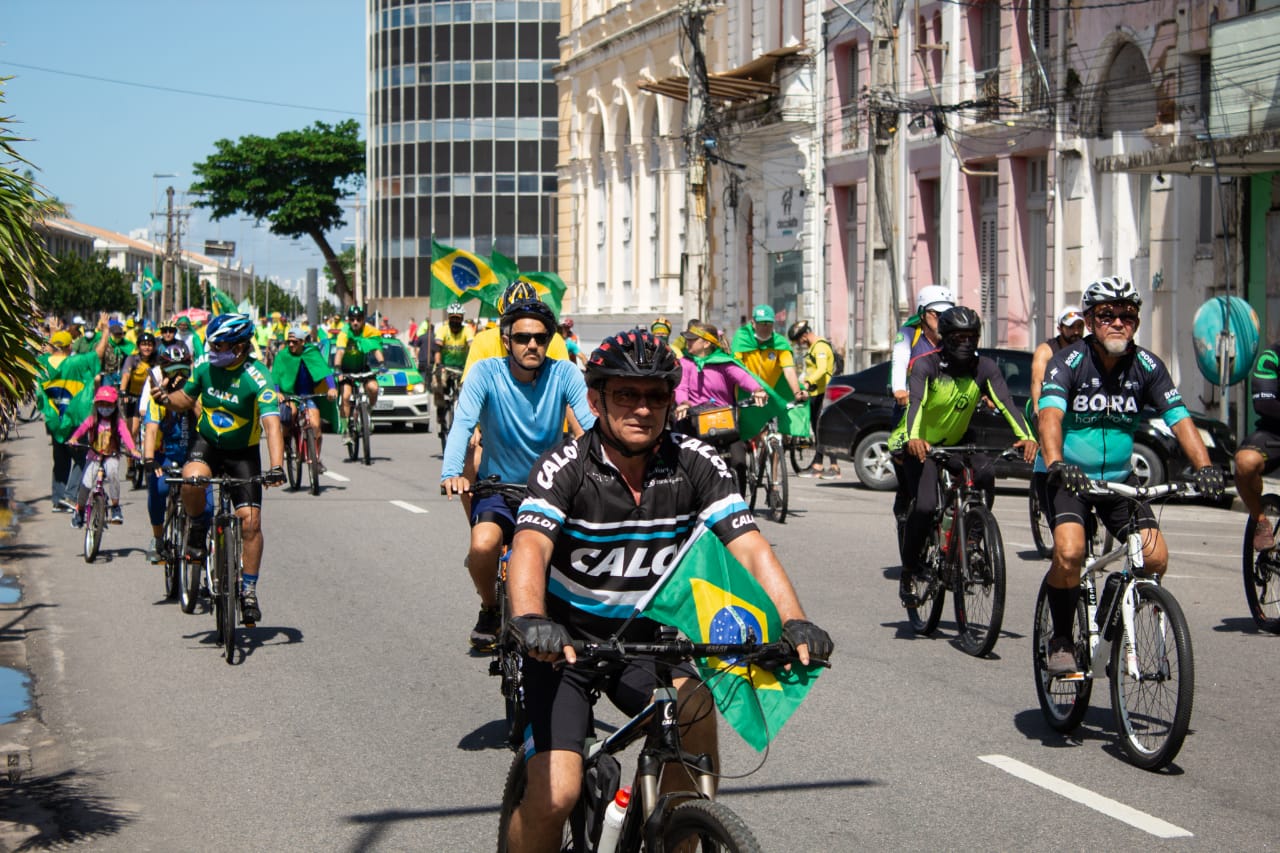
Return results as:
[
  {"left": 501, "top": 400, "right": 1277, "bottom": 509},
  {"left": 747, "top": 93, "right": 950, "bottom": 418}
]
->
[{"left": 1032, "top": 480, "right": 1198, "bottom": 770}]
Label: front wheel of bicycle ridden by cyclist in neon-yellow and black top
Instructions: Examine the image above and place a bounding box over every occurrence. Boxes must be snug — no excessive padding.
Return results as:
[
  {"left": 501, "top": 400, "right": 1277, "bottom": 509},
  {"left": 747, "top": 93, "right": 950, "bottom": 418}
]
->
[{"left": 952, "top": 505, "right": 1005, "bottom": 657}]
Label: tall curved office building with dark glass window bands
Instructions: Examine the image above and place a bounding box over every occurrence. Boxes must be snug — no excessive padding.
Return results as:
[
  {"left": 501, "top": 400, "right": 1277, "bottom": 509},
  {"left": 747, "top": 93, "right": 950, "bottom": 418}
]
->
[{"left": 366, "top": 0, "right": 561, "bottom": 298}]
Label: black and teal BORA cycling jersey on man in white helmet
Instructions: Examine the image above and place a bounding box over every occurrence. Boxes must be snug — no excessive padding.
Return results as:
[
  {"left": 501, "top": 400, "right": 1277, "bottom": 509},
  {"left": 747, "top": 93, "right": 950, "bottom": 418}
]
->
[{"left": 1041, "top": 338, "right": 1190, "bottom": 480}]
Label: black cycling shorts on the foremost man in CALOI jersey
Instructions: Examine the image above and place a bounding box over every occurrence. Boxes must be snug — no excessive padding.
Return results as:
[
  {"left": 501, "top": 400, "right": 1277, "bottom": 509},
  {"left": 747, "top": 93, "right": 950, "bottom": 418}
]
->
[{"left": 522, "top": 657, "right": 698, "bottom": 756}]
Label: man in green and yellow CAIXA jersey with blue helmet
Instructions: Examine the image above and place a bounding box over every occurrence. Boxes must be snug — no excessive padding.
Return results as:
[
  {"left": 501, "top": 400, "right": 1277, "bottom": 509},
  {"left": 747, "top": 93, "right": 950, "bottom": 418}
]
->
[{"left": 151, "top": 314, "right": 284, "bottom": 626}]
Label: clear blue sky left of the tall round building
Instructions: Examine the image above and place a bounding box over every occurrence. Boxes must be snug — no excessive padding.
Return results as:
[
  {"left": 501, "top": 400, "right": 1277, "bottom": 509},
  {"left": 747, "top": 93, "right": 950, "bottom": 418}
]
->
[{"left": 0, "top": 0, "right": 365, "bottom": 289}]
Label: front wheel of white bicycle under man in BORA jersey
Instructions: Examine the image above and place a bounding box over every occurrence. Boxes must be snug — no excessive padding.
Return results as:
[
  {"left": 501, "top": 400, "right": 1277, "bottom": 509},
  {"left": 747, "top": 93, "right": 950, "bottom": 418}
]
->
[{"left": 1111, "top": 583, "right": 1196, "bottom": 770}]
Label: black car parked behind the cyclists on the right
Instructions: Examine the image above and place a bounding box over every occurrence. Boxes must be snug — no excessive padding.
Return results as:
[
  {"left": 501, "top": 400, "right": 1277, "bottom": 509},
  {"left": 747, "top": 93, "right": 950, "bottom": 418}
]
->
[{"left": 818, "top": 348, "right": 1235, "bottom": 491}]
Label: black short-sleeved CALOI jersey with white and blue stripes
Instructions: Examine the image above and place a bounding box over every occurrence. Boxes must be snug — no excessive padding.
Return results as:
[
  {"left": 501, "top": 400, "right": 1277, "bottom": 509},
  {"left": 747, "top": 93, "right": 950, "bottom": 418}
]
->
[{"left": 516, "top": 427, "right": 758, "bottom": 640}]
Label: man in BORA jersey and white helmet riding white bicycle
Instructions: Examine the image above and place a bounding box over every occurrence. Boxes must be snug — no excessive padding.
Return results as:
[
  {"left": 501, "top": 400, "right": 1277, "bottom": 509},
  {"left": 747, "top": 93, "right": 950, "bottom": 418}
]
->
[{"left": 1039, "top": 275, "right": 1222, "bottom": 675}]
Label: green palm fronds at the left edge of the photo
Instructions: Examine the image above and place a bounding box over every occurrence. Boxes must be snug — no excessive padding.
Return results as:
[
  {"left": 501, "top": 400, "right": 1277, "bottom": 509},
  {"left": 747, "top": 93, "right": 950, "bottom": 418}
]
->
[{"left": 0, "top": 77, "right": 59, "bottom": 402}]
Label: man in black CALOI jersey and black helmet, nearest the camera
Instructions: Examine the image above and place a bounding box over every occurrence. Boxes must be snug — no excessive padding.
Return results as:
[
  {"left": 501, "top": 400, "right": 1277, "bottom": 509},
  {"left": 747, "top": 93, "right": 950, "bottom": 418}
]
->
[{"left": 508, "top": 329, "right": 832, "bottom": 850}]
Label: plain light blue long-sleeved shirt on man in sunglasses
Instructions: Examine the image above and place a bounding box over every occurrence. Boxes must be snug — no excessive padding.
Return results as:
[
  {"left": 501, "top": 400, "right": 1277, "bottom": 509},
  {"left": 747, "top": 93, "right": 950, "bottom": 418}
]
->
[{"left": 440, "top": 356, "right": 595, "bottom": 483}]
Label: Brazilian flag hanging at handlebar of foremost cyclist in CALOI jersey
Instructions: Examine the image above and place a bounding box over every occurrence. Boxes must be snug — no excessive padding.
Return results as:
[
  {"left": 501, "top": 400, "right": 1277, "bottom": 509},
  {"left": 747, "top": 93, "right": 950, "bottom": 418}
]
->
[{"left": 641, "top": 528, "right": 818, "bottom": 752}]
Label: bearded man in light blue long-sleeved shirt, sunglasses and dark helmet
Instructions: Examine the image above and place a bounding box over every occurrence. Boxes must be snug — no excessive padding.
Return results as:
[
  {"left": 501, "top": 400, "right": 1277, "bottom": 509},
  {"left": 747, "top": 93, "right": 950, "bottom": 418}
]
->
[{"left": 440, "top": 300, "right": 595, "bottom": 649}]
